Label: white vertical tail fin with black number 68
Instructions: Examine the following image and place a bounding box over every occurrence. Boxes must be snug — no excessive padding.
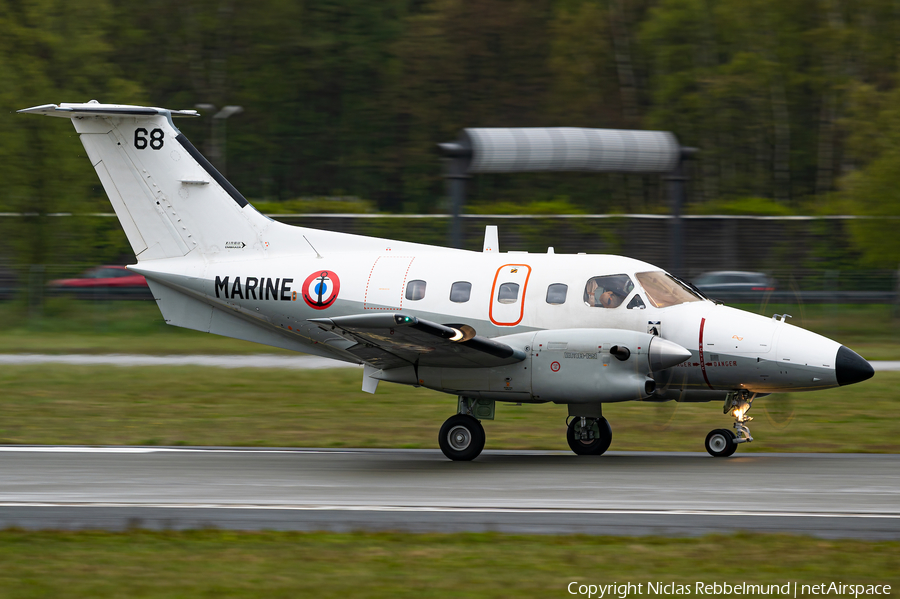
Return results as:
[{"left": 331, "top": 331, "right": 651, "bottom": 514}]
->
[{"left": 19, "top": 101, "right": 270, "bottom": 261}]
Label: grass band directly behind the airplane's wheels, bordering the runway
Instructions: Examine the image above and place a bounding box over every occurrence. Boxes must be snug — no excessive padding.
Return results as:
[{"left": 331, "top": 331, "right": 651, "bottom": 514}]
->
[{"left": 0, "top": 366, "right": 900, "bottom": 453}]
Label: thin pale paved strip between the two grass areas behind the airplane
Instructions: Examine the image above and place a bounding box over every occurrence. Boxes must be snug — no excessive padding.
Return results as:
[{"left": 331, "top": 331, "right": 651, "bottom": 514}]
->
[{"left": 0, "top": 354, "right": 900, "bottom": 372}]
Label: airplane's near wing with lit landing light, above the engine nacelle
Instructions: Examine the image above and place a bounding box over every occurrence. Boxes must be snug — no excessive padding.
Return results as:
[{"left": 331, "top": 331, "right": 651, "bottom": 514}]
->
[{"left": 310, "top": 313, "right": 525, "bottom": 369}]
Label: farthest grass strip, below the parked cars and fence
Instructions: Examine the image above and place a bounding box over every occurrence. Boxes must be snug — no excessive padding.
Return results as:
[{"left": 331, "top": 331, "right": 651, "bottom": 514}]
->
[{"left": 0, "top": 298, "right": 900, "bottom": 360}]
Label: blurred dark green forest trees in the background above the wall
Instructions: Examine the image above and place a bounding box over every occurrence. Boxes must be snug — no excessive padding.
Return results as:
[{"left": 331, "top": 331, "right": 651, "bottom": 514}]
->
[{"left": 0, "top": 0, "right": 900, "bottom": 266}]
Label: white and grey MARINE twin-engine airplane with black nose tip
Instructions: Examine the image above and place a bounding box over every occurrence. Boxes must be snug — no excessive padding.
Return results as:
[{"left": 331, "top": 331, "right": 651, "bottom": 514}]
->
[{"left": 19, "top": 100, "right": 874, "bottom": 461}]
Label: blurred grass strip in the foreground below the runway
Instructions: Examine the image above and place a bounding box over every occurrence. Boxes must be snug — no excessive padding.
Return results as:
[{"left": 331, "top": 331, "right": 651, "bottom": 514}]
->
[{"left": 0, "top": 531, "right": 900, "bottom": 599}]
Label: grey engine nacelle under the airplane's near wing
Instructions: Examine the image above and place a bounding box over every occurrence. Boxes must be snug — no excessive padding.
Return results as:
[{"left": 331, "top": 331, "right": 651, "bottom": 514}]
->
[{"left": 408, "top": 329, "right": 691, "bottom": 403}]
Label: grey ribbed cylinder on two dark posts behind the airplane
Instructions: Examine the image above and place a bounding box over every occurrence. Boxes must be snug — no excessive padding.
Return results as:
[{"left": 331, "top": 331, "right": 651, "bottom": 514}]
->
[{"left": 438, "top": 127, "right": 696, "bottom": 272}]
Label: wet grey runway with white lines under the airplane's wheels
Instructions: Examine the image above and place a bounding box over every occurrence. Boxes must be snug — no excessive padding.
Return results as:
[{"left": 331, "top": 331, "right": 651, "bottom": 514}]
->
[{"left": 0, "top": 446, "right": 900, "bottom": 539}]
